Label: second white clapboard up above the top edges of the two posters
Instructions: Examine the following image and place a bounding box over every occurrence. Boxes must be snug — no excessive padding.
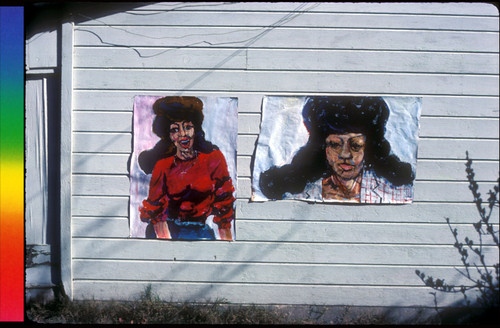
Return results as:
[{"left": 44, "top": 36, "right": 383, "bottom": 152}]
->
[{"left": 75, "top": 47, "right": 498, "bottom": 74}]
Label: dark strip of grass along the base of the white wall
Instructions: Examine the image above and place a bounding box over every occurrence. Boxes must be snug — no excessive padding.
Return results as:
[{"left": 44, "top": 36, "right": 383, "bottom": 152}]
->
[{"left": 25, "top": 286, "right": 498, "bottom": 325}]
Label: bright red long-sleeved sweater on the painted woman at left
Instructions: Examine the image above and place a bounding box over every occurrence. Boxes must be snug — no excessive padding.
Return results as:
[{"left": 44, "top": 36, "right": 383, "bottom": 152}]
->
[{"left": 139, "top": 150, "right": 235, "bottom": 229}]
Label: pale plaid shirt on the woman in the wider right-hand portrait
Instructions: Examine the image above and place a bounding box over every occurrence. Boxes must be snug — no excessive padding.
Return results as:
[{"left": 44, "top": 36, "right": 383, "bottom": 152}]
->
[{"left": 283, "top": 170, "right": 413, "bottom": 204}]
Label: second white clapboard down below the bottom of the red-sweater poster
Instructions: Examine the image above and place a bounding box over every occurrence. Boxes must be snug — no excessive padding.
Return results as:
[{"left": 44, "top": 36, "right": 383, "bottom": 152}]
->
[{"left": 73, "top": 259, "right": 484, "bottom": 287}]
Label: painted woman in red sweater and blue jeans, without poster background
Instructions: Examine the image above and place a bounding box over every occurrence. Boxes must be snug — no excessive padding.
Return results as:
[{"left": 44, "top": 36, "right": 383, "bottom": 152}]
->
[{"left": 130, "top": 96, "right": 235, "bottom": 240}]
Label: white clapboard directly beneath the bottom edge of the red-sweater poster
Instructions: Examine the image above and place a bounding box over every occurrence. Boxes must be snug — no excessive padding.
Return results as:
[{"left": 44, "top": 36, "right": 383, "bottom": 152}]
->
[{"left": 73, "top": 238, "right": 498, "bottom": 266}]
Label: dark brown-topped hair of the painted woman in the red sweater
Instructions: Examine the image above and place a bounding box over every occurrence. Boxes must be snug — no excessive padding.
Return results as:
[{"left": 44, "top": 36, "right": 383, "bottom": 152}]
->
[{"left": 138, "top": 96, "right": 218, "bottom": 174}]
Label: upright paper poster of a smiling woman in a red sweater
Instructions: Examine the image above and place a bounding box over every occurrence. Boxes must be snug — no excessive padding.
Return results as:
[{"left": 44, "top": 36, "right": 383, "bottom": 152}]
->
[{"left": 130, "top": 96, "right": 238, "bottom": 240}]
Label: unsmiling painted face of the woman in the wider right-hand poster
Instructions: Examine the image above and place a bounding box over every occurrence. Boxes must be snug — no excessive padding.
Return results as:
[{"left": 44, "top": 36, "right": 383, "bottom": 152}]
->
[{"left": 326, "top": 133, "right": 366, "bottom": 180}]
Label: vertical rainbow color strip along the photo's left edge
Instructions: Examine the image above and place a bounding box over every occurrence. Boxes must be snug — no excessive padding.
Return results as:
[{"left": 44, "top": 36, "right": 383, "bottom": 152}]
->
[{"left": 0, "top": 7, "right": 24, "bottom": 321}]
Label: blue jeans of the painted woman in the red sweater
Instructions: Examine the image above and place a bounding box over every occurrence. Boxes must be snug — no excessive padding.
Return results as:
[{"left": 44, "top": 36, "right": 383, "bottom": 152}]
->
[{"left": 146, "top": 219, "right": 215, "bottom": 240}]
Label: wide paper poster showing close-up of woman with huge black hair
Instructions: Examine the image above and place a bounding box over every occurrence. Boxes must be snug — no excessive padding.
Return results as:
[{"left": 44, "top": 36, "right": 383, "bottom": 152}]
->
[{"left": 252, "top": 96, "right": 421, "bottom": 204}]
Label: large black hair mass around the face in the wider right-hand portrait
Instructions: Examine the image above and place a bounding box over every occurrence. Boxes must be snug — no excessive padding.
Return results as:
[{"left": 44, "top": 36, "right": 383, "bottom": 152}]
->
[{"left": 259, "top": 96, "right": 415, "bottom": 199}]
